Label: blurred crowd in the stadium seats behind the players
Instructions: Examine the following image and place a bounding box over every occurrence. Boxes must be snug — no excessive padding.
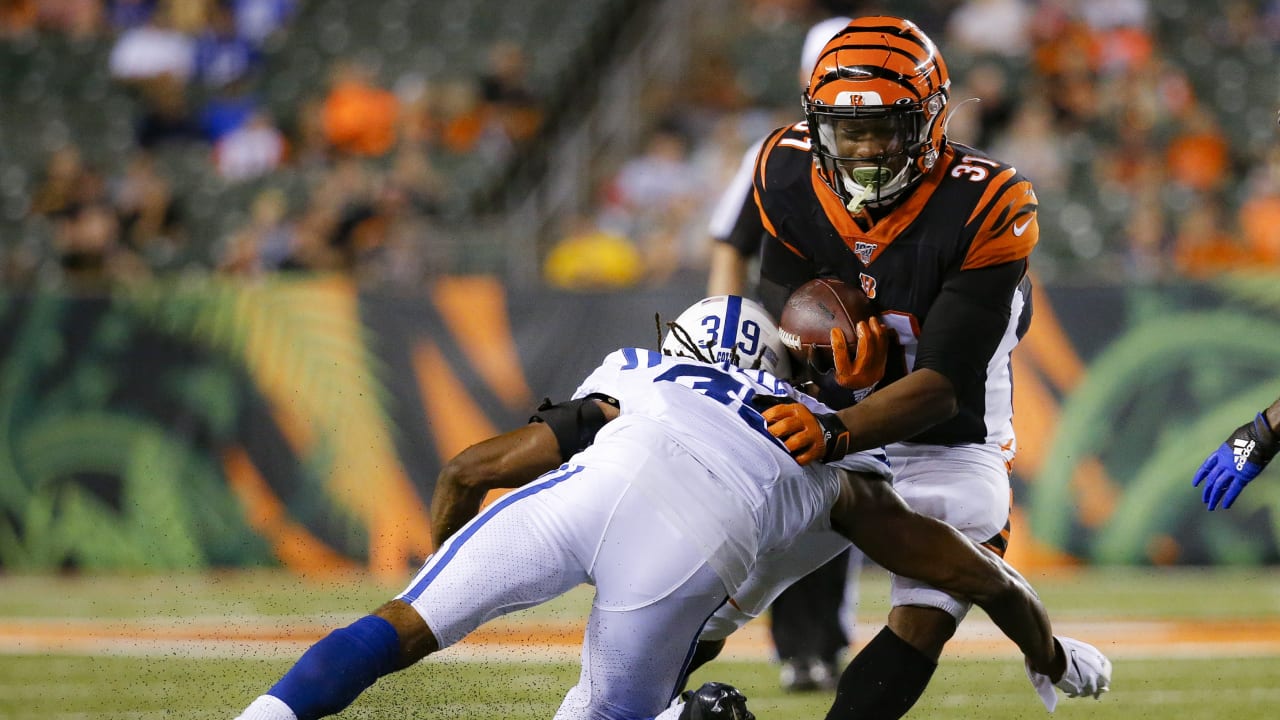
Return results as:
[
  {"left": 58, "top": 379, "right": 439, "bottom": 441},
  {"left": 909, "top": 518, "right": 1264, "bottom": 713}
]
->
[{"left": 0, "top": 0, "right": 1280, "bottom": 292}]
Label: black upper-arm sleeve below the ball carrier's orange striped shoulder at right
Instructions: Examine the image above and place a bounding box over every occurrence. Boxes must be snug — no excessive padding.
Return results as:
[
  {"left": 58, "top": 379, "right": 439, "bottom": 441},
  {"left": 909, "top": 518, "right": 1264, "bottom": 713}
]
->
[{"left": 914, "top": 260, "right": 1027, "bottom": 395}]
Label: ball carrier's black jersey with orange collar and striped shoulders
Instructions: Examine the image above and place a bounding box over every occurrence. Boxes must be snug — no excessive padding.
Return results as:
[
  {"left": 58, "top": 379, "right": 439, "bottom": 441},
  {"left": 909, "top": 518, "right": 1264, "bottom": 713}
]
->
[{"left": 754, "top": 123, "right": 1039, "bottom": 447}]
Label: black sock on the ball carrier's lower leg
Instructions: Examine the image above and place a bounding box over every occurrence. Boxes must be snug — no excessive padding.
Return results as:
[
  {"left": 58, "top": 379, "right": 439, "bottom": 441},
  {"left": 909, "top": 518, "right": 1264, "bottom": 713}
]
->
[{"left": 827, "top": 628, "right": 938, "bottom": 720}]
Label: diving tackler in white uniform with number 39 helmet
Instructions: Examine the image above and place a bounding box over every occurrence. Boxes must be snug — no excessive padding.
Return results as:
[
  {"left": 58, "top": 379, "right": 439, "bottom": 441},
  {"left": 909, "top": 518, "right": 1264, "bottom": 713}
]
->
[{"left": 241, "top": 296, "right": 890, "bottom": 720}]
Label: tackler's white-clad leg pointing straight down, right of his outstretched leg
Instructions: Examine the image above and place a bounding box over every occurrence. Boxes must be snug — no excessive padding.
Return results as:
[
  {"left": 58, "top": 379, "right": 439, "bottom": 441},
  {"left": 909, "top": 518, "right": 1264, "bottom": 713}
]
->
[{"left": 556, "top": 479, "right": 727, "bottom": 720}]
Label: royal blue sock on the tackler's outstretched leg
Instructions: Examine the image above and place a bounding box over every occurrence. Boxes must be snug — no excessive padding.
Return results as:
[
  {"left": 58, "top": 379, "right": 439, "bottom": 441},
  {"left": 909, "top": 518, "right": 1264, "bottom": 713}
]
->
[{"left": 255, "top": 615, "right": 399, "bottom": 720}]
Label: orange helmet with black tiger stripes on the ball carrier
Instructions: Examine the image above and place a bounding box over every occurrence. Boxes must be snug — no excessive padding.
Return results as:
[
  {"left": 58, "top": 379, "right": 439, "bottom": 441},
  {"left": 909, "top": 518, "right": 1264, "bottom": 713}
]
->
[{"left": 804, "top": 17, "right": 951, "bottom": 213}]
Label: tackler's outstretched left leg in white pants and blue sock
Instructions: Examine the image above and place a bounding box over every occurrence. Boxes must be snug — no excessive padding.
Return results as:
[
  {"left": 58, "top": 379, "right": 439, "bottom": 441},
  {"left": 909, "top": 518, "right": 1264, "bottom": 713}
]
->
[{"left": 241, "top": 468, "right": 601, "bottom": 720}]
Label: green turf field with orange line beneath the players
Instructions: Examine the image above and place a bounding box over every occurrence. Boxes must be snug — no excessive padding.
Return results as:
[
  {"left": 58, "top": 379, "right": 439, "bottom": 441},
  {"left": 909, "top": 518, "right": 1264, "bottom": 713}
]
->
[{"left": 0, "top": 569, "right": 1280, "bottom": 720}]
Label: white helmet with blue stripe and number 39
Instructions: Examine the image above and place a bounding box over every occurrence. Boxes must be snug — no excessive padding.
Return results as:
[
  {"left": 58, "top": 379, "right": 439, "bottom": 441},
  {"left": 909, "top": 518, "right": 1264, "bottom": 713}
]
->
[{"left": 662, "top": 295, "right": 791, "bottom": 379}]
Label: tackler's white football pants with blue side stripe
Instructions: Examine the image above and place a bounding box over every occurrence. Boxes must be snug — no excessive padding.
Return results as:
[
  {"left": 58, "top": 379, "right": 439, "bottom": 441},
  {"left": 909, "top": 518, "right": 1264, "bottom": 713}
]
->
[{"left": 399, "top": 455, "right": 727, "bottom": 720}]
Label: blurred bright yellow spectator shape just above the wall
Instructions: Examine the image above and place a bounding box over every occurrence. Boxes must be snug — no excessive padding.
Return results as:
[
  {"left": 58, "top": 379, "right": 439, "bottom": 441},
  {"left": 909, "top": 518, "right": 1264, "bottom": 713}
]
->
[{"left": 543, "top": 218, "right": 645, "bottom": 290}]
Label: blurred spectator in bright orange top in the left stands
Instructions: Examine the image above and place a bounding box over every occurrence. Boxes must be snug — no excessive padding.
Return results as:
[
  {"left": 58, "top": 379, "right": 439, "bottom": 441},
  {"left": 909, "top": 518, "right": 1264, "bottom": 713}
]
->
[{"left": 324, "top": 60, "right": 399, "bottom": 158}]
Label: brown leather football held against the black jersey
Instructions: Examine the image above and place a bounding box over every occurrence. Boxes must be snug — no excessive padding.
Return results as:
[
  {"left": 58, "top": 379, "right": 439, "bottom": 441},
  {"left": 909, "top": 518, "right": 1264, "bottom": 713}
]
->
[{"left": 778, "top": 278, "right": 876, "bottom": 366}]
